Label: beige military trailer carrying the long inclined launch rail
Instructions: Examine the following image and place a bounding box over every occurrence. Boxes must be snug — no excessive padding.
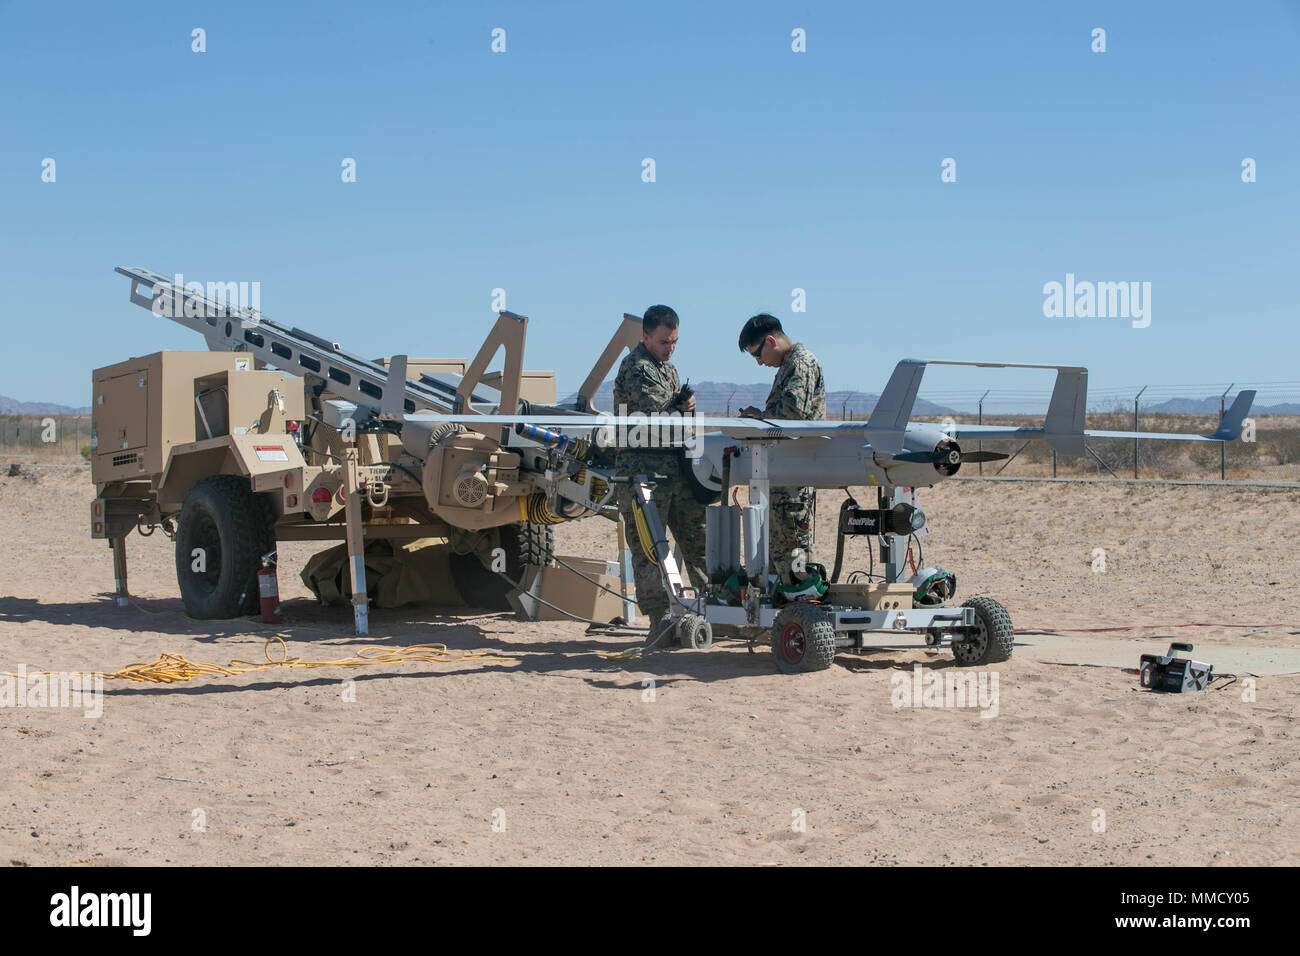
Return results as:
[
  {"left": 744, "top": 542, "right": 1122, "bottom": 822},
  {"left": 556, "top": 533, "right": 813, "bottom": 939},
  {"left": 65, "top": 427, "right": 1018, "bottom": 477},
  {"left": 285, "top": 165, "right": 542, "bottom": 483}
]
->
[{"left": 91, "top": 268, "right": 641, "bottom": 633}]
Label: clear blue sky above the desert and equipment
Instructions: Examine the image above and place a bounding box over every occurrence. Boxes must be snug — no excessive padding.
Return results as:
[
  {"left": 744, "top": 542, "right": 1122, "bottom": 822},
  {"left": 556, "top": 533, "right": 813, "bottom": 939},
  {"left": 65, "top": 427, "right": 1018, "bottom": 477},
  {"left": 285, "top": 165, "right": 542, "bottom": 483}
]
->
[{"left": 0, "top": 0, "right": 1300, "bottom": 405}]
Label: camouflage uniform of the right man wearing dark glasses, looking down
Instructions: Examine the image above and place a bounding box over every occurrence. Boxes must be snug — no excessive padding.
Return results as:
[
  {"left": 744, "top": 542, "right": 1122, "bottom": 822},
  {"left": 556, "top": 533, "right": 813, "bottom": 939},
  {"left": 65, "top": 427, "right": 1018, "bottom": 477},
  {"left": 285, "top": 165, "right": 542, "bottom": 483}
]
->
[{"left": 763, "top": 342, "right": 826, "bottom": 584}]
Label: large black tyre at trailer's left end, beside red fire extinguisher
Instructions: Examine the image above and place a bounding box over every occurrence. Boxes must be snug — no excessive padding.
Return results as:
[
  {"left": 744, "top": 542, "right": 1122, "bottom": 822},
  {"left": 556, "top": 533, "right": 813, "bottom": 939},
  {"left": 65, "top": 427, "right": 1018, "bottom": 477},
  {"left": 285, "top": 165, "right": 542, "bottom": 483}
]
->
[{"left": 176, "top": 475, "right": 276, "bottom": 620}]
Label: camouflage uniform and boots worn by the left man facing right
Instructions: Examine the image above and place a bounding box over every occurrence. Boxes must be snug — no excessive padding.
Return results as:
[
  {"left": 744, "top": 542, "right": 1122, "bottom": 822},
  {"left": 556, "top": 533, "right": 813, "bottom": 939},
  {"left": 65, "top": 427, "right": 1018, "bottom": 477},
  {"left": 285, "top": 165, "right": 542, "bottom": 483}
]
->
[{"left": 614, "top": 342, "right": 709, "bottom": 623}]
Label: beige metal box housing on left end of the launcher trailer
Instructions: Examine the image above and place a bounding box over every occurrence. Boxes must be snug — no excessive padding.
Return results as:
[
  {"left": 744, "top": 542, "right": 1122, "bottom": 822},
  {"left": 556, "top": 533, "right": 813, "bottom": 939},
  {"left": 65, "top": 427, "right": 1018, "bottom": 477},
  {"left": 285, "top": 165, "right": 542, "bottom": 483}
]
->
[{"left": 90, "top": 351, "right": 303, "bottom": 484}]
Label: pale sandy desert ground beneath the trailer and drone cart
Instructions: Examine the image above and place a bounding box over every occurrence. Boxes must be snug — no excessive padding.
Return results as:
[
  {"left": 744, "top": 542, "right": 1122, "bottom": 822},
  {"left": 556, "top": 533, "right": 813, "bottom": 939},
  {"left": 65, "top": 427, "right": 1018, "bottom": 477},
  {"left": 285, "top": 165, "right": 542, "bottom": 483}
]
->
[{"left": 0, "top": 468, "right": 1300, "bottom": 865}]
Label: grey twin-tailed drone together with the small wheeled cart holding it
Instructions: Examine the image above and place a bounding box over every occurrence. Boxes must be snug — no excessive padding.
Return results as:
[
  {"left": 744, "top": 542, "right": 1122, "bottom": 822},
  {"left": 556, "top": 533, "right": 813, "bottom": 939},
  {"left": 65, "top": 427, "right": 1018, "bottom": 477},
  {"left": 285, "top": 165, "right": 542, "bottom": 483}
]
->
[{"left": 408, "top": 359, "right": 1255, "bottom": 674}]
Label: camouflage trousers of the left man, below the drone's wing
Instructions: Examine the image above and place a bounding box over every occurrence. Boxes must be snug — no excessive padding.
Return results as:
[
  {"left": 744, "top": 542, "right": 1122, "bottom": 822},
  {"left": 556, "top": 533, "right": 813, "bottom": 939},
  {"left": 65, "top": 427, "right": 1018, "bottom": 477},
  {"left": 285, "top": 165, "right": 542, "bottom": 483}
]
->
[{"left": 615, "top": 457, "right": 709, "bottom": 618}]
